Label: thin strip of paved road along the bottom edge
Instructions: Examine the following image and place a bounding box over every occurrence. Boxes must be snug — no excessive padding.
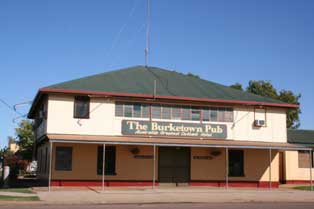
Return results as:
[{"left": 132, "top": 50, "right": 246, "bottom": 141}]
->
[{"left": 0, "top": 203, "right": 314, "bottom": 209}]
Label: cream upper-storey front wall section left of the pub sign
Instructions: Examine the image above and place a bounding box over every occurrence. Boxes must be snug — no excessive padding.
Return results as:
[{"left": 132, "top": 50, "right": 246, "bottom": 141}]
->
[{"left": 47, "top": 95, "right": 114, "bottom": 135}]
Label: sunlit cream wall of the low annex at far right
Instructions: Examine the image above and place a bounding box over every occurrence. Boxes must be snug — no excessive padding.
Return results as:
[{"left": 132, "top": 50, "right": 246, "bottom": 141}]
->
[{"left": 285, "top": 151, "right": 314, "bottom": 181}]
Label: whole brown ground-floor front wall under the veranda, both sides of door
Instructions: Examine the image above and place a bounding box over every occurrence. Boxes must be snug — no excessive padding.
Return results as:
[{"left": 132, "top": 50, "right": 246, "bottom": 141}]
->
[{"left": 35, "top": 143, "right": 279, "bottom": 181}]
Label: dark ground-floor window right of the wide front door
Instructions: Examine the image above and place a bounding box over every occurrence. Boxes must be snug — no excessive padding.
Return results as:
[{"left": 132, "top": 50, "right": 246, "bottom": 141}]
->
[{"left": 229, "top": 150, "right": 244, "bottom": 177}]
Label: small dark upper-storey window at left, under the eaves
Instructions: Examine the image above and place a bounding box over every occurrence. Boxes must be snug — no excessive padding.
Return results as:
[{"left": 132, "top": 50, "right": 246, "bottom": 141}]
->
[{"left": 74, "top": 96, "right": 90, "bottom": 118}]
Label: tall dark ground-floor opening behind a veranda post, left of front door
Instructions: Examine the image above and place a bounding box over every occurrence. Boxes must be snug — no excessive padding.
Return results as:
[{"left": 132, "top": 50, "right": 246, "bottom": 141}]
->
[{"left": 97, "top": 146, "right": 116, "bottom": 175}]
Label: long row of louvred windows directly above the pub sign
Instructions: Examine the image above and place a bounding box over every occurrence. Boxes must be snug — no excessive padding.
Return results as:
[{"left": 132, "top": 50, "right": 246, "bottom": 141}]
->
[{"left": 115, "top": 102, "right": 233, "bottom": 122}]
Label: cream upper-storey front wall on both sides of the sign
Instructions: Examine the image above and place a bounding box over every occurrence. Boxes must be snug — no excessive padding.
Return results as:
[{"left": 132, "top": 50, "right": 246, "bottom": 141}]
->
[{"left": 47, "top": 95, "right": 287, "bottom": 142}]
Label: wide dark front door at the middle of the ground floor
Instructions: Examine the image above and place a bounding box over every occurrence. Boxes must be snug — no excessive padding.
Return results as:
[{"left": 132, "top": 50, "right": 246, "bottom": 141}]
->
[{"left": 158, "top": 147, "right": 190, "bottom": 183}]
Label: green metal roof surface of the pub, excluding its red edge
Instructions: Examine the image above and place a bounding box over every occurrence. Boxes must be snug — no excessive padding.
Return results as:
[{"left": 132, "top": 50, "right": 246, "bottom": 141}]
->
[{"left": 46, "top": 66, "right": 285, "bottom": 104}]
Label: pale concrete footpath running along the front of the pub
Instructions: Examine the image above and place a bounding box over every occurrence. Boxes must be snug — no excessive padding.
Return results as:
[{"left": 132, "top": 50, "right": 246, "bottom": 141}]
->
[{"left": 36, "top": 187, "right": 314, "bottom": 204}]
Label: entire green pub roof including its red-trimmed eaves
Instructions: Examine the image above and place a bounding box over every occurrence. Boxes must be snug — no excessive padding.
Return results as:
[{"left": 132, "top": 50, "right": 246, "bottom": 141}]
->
[{"left": 28, "top": 66, "right": 298, "bottom": 118}]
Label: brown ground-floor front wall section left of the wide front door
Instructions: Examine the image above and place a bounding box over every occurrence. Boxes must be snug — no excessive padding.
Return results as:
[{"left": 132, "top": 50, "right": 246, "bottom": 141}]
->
[{"left": 52, "top": 144, "right": 158, "bottom": 181}]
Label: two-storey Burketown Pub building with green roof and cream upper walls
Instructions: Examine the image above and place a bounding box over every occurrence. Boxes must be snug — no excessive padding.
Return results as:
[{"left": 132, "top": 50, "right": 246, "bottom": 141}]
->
[{"left": 29, "top": 66, "right": 311, "bottom": 187}]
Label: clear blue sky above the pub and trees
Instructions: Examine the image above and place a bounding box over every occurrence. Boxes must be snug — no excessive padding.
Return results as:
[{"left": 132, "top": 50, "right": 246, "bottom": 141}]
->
[{"left": 0, "top": 0, "right": 314, "bottom": 146}]
